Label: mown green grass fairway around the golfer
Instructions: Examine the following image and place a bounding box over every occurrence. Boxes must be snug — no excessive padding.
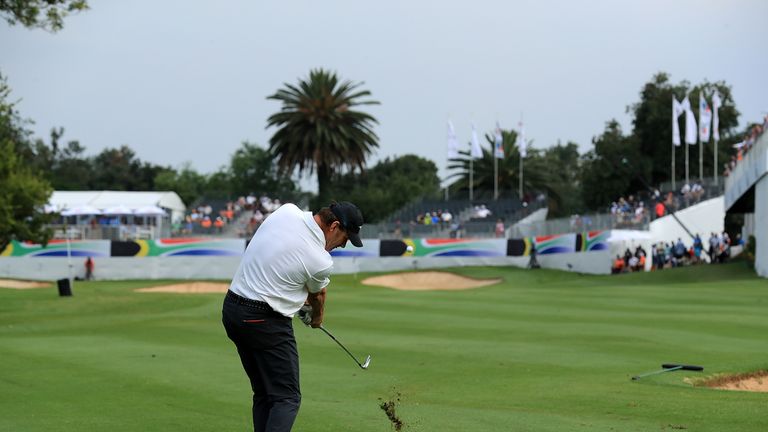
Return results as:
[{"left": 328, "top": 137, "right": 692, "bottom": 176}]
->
[{"left": 0, "top": 263, "right": 768, "bottom": 432}]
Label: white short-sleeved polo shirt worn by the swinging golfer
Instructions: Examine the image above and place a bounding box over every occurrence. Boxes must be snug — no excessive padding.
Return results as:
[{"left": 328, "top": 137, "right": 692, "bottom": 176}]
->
[{"left": 229, "top": 204, "right": 333, "bottom": 317}]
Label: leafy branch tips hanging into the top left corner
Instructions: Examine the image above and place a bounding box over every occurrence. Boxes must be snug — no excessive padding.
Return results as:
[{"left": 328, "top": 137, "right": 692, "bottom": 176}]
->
[{"left": 0, "top": 0, "right": 88, "bottom": 32}]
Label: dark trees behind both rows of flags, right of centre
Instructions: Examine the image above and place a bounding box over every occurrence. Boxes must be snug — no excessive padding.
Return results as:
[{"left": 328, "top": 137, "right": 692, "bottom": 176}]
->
[{"left": 449, "top": 72, "right": 752, "bottom": 217}]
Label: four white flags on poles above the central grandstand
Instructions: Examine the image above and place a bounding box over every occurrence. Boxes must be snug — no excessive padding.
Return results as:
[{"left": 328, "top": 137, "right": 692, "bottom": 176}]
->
[{"left": 448, "top": 119, "right": 527, "bottom": 201}]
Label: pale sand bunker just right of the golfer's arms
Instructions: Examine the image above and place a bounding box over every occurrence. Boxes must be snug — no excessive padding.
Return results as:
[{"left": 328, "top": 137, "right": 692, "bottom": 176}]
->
[{"left": 363, "top": 272, "right": 501, "bottom": 291}]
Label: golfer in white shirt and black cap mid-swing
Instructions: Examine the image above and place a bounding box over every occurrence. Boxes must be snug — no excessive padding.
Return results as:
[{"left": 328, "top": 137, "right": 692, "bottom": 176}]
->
[{"left": 222, "top": 202, "right": 363, "bottom": 432}]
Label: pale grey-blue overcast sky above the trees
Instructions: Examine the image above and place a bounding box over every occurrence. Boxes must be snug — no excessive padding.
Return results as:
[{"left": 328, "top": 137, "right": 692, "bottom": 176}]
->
[{"left": 0, "top": 0, "right": 768, "bottom": 187}]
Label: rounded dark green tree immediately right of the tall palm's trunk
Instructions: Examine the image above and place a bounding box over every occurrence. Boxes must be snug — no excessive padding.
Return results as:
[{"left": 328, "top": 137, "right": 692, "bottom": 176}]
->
[{"left": 331, "top": 155, "right": 440, "bottom": 223}]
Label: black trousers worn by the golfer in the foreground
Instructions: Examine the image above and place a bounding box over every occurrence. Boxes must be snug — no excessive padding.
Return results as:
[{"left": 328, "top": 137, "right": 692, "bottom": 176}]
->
[{"left": 222, "top": 292, "right": 301, "bottom": 432}]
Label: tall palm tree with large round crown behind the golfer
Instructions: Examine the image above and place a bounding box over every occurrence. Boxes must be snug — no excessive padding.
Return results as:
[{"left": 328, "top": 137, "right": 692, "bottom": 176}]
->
[{"left": 267, "top": 69, "right": 379, "bottom": 205}]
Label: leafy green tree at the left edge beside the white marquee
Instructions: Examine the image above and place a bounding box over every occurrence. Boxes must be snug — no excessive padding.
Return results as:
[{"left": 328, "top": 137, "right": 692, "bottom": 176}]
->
[{"left": 0, "top": 75, "right": 52, "bottom": 251}]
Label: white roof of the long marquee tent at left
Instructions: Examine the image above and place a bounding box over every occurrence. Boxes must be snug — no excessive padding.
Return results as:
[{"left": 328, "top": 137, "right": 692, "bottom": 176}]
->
[{"left": 48, "top": 191, "right": 186, "bottom": 222}]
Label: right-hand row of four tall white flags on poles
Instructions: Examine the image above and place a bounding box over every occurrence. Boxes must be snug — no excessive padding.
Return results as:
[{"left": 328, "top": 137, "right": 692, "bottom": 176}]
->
[{"left": 672, "top": 91, "right": 723, "bottom": 189}]
